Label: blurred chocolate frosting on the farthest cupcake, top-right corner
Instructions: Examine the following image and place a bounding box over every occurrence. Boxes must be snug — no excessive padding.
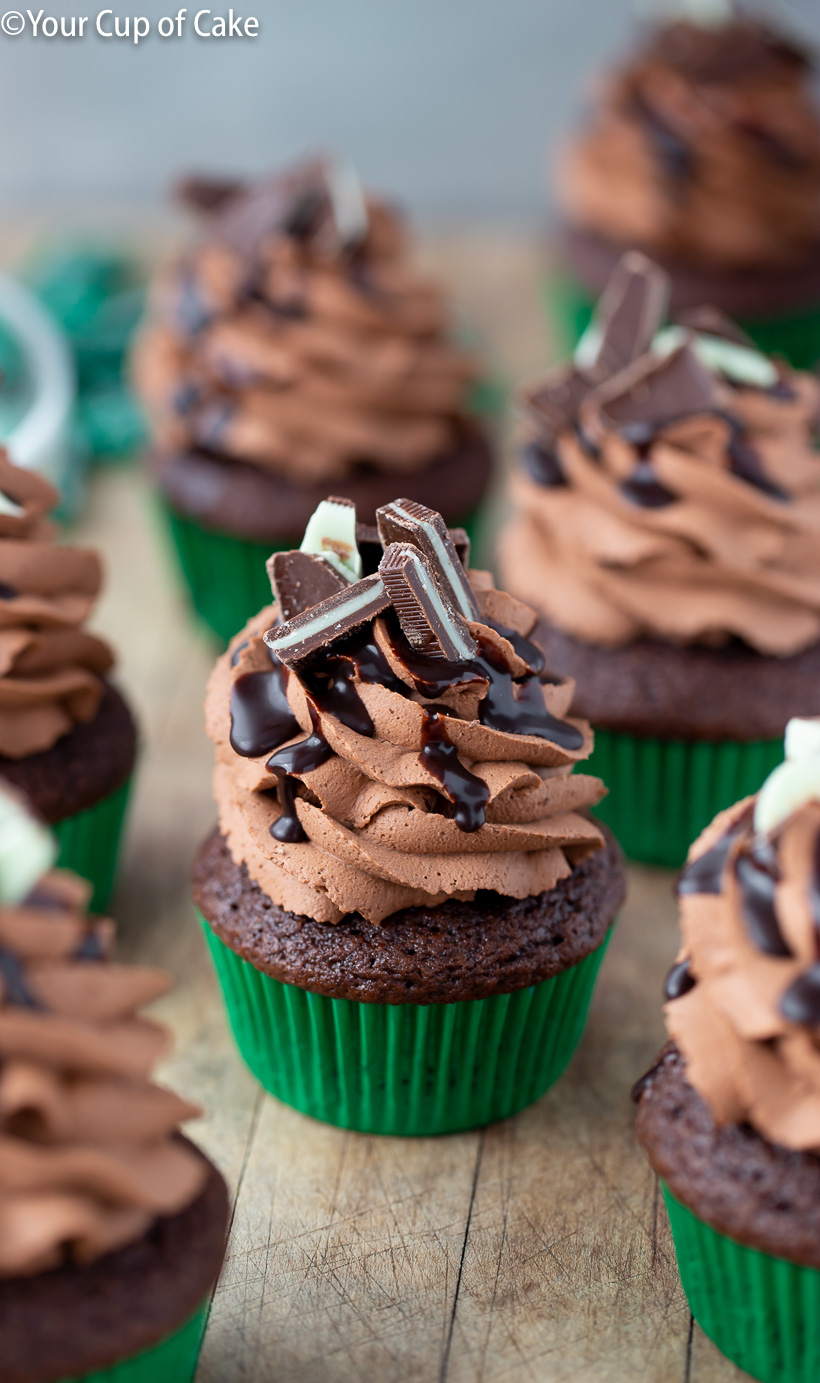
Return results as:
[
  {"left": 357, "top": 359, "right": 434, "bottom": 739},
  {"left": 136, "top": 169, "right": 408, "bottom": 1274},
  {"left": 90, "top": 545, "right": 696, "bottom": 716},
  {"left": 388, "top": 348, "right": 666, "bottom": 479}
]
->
[{"left": 557, "top": 14, "right": 820, "bottom": 271}]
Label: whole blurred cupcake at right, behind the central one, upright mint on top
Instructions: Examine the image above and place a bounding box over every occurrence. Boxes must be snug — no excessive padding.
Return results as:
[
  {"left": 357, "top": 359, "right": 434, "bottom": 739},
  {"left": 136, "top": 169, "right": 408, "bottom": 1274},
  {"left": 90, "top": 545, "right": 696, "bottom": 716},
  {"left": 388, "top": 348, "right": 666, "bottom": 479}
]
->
[{"left": 499, "top": 253, "right": 820, "bottom": 866}]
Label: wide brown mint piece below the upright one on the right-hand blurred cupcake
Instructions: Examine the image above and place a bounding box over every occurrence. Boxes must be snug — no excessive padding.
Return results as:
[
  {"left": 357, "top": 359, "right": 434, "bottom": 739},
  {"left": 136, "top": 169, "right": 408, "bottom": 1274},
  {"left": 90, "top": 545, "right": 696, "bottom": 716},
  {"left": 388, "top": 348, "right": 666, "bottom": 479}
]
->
[{"left": 590, "top": 346, "right": 718, "bottom": 429}]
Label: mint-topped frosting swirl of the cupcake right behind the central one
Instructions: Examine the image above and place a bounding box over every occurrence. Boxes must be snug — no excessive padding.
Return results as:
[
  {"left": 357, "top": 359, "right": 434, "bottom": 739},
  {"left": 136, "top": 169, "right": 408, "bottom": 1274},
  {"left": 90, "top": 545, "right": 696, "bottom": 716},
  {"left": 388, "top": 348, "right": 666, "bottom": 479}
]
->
[{"left": 499, "top": 253, "right": 820, "bottom": 657}]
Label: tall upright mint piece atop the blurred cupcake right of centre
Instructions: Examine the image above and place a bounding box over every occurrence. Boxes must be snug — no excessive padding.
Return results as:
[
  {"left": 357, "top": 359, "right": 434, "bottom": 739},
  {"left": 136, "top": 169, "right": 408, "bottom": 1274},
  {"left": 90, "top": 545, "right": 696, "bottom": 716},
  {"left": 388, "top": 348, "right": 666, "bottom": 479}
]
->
[{"left": 575, "top": 250, "right": 669, "bottom": 379}]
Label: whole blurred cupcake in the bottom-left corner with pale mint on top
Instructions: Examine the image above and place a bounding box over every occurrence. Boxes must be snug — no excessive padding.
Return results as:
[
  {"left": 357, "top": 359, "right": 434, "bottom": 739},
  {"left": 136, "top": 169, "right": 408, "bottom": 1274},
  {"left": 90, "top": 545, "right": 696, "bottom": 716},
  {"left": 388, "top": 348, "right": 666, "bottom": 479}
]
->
[{"left": 0, "top": 791, "right": 228, "bottom": 1383}]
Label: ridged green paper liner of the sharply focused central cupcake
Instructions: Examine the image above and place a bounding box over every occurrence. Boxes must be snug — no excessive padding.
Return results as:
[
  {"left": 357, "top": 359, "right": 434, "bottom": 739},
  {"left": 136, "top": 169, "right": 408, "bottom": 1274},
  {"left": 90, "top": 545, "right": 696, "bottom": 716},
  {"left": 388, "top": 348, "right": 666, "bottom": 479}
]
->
[{"left": 198, "top": 914, "right": 611, "bottom": 1137}]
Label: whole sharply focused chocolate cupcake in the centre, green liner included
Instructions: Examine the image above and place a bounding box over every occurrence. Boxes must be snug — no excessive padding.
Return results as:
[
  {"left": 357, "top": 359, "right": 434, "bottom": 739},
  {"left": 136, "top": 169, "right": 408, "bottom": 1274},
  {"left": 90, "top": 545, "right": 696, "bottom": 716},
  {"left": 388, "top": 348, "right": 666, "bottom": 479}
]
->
[{"left": 194, "top": 499, "right": 624, "bottom": 1134}]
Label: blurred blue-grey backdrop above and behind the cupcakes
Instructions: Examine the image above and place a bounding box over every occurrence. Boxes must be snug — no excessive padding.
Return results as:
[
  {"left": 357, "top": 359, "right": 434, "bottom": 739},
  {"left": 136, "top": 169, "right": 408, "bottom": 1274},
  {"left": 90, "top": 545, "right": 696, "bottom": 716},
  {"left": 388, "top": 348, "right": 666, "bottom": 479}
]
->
[{"left": 0, "top": 0, "right": 820, "bottom": 224}]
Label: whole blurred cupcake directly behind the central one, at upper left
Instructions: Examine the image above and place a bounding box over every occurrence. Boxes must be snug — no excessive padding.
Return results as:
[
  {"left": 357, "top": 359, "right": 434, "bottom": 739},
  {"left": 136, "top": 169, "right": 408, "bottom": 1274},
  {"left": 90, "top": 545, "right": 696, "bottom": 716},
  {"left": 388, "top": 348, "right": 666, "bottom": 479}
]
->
[{"left": 134, "top": 162, "right": 491, "bottom": 642}]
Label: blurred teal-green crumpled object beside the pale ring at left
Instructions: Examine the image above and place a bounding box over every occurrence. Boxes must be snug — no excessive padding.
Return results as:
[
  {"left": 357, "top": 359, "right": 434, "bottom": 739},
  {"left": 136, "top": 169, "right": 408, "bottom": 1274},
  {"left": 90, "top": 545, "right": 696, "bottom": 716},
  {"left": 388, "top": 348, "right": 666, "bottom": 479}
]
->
[{"left": 26, "top": 246, "right": 145, "bottom": 462}]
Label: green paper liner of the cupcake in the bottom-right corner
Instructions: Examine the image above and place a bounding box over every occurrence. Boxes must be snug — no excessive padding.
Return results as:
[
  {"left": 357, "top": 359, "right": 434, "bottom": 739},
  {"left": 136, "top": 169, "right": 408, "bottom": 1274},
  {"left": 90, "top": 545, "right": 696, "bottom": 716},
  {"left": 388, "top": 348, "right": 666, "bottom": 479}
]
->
[{"left": 664, "top": 1187, "right": 820, "bottom": 1383}]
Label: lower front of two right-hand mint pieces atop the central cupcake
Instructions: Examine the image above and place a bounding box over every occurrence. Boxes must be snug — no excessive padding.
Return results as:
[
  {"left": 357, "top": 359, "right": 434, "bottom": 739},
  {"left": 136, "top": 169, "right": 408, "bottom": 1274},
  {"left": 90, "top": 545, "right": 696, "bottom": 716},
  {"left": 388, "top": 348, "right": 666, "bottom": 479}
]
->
[{"left": 379, "top": 542, "right": 477, "bottom": 662}]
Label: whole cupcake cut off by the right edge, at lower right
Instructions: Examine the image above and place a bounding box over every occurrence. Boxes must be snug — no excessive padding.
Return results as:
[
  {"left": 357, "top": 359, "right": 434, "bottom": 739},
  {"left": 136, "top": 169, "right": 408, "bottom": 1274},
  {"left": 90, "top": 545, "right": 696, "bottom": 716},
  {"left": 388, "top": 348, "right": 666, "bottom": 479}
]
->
[{"left": 635, "top": 719, "right": 820, "bottom": 1383}]
